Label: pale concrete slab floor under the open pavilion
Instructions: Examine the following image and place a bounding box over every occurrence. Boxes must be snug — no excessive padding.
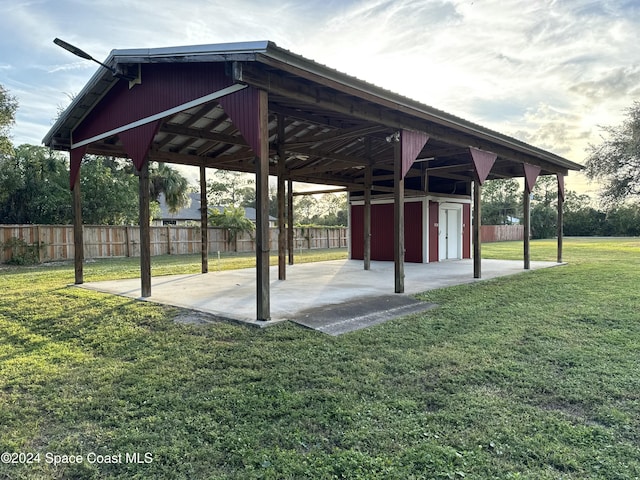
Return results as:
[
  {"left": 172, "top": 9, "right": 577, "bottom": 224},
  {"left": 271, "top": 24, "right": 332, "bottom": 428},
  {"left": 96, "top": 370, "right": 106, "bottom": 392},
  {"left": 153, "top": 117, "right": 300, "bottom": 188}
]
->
[{"left": 81, "top": 260, "right": 559, "bottom": 326}]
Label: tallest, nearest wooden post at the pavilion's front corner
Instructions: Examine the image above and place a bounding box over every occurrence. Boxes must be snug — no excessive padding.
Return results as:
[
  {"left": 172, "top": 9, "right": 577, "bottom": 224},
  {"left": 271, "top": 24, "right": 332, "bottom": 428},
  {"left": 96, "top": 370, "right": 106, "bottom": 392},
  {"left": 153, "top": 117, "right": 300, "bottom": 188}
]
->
[{"left": 256, "top": 90, "right": 271, "bottom": 321}]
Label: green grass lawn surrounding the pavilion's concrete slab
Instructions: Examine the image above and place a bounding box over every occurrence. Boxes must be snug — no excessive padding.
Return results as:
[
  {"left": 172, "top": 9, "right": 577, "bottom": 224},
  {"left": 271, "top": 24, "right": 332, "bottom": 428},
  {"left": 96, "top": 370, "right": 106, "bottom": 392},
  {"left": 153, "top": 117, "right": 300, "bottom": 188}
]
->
[{"left": 0, "top": 238, "right": 640, "bottom": 480}]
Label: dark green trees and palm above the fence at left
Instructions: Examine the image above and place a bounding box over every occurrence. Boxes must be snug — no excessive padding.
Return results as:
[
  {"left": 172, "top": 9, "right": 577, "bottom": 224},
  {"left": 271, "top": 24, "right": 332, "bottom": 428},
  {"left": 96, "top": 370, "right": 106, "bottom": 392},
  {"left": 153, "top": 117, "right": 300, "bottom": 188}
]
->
[{"left": 0, "top": 145, "right": 189, "bottom": 225}]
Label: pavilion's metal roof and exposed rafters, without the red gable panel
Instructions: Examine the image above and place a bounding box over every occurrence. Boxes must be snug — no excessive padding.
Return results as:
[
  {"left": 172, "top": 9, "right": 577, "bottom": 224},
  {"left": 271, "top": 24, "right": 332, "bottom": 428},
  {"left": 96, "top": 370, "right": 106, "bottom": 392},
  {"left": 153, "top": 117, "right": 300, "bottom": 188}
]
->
[{"left": 43, "top": 41, "right": 582, "bottom": 191}]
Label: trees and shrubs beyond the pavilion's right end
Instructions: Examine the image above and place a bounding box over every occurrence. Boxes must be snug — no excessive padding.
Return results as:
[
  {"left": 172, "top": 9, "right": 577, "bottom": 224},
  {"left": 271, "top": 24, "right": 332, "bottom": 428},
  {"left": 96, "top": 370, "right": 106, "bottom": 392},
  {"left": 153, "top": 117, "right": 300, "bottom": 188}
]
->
[{"left": 482, "top": 101, "right": 640, "bottom": 238}]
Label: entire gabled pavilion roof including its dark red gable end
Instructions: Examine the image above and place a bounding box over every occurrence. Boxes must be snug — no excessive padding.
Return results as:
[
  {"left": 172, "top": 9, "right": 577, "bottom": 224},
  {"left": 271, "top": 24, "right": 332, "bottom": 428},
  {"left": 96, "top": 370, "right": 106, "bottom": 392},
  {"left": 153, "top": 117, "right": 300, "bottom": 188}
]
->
[{"left": 43, "top": 41, "right": 581, "bottom": 191}]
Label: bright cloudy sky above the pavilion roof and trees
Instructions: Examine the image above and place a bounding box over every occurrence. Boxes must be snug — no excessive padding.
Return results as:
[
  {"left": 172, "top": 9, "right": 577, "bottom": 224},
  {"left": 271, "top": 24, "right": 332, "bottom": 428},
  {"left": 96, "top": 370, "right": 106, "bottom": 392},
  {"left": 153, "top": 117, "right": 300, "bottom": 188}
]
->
[{"left": 0, "top": 0, "right": 640, "bottom": 195}]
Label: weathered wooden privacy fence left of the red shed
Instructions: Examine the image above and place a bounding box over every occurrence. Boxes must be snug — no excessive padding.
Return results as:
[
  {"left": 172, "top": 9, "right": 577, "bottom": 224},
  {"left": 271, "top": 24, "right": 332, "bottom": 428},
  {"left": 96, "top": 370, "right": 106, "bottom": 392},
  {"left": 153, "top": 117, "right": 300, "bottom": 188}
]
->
[{"left": 0, "top": 225, "right": 348, "bottom": 262}]
